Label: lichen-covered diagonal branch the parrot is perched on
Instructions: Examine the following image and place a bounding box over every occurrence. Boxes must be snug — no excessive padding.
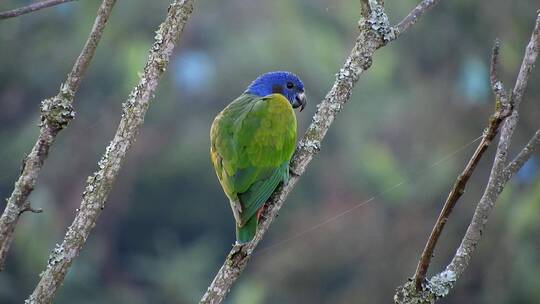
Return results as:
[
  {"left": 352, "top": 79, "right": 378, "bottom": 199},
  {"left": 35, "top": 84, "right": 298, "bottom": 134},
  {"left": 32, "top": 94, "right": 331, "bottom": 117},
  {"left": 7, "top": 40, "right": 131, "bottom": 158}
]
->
[{"left": 200, "top": 0, "right": 442, "bottom": 304}]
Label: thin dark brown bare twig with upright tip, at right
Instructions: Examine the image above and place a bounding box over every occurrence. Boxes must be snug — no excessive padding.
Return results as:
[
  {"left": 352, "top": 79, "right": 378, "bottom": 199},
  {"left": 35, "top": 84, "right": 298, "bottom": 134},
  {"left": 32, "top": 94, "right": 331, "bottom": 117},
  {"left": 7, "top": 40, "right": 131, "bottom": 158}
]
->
[{"left": 414, "top": 41, "right": 512, "bottom": 290}]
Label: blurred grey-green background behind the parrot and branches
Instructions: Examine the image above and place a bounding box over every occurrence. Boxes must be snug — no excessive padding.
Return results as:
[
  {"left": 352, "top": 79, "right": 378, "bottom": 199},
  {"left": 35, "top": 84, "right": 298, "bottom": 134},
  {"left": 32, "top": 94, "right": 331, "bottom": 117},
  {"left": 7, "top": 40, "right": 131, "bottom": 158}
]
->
[{"left": 0, "top": 0, "right": 540, "bottom": 304}]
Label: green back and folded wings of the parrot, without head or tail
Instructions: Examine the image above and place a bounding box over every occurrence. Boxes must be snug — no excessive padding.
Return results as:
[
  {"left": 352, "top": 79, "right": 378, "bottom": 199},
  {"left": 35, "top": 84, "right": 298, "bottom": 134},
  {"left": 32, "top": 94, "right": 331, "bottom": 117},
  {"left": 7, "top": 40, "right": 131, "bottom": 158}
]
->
[{"left": 211, "top": 94, "right": 296, "bottom": 226}]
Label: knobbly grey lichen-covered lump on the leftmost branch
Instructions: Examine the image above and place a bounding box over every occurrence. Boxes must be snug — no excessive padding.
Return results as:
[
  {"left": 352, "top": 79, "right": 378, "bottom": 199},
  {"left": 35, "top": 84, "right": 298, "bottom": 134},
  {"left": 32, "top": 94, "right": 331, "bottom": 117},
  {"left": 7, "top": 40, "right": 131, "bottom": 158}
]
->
[{"left": 41, "top": 84, "right": 75, "bottom": 129}]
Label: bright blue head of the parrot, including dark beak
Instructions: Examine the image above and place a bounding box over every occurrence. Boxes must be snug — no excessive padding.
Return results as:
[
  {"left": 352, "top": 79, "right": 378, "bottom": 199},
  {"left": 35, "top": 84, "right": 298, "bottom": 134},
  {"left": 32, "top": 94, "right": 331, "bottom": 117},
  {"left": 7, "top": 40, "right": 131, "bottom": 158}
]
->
[{"left": 246, "top": 71, "right": 307, "bottom": 111}]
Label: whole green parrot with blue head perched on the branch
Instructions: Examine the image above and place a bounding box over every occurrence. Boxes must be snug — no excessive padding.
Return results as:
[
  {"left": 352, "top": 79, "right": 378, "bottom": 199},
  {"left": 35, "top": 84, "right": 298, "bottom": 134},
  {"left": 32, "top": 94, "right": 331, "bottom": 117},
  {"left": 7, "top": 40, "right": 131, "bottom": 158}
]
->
[{"left": 210, "top": 71, "right": 307, "bottom": 244}]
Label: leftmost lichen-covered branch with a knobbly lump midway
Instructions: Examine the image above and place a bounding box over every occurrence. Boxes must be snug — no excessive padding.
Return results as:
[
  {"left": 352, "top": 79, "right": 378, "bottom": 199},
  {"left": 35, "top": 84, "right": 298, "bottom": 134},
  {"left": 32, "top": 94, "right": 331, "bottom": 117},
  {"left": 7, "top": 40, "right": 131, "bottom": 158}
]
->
[{"left": 0, "top": 0, "right": 116, "bottom": 270}]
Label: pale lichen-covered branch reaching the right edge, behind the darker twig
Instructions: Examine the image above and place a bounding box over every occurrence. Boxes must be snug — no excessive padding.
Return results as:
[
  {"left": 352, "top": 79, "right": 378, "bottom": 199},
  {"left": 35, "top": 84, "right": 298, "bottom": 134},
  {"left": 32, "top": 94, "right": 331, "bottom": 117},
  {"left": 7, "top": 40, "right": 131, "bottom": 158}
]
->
[{"left": 394, "top": 12, "right": 540, "bottom": 304}]
